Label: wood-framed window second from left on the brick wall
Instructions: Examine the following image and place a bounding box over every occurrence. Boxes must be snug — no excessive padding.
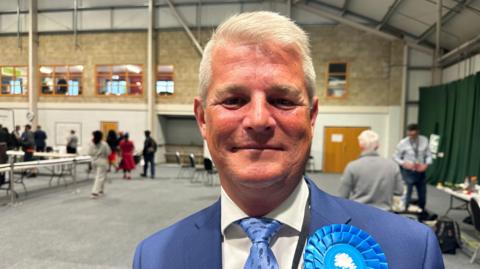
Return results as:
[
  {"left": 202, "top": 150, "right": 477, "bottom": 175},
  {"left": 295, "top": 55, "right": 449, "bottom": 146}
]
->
[{"left": 40, "top": 65, "right": 83, "bottom": 96}]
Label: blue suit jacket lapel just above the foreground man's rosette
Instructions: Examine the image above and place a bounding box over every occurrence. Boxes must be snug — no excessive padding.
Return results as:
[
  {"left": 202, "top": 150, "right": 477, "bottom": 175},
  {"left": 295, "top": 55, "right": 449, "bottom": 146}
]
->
[{"left": 305, "top": 177, "right": 351, "bottom": 235}]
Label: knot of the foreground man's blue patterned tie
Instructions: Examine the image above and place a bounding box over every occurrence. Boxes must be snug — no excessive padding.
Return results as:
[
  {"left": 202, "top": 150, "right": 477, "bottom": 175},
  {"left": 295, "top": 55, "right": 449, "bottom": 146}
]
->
[{"left": 238, "top": 218, "right": 282, "bottom": 244}]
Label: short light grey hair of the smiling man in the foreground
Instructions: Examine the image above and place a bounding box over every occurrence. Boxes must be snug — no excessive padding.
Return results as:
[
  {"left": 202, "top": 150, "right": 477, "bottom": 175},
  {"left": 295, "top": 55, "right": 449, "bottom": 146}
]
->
[{"left": 199, "top": 11, "right": 316, "bottom": 104}]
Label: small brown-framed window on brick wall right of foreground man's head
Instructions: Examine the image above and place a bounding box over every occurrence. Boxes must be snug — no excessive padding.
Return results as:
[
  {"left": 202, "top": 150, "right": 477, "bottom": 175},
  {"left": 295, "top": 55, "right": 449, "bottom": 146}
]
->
[{"left": 327, "top": 63, "right": 347, "bottom": 98}]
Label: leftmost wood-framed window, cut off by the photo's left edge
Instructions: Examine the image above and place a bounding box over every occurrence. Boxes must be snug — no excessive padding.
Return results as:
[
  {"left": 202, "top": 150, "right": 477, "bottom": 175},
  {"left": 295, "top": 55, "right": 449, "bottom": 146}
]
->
[{"left": 0, "top": 66, "right": 28, "bottom": 95}]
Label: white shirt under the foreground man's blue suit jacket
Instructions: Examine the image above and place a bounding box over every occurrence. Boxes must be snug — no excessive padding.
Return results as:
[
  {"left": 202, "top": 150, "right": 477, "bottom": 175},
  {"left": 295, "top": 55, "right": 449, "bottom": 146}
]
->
[{"left": 221, "top": 179, "right": 309, "bottom": 269}]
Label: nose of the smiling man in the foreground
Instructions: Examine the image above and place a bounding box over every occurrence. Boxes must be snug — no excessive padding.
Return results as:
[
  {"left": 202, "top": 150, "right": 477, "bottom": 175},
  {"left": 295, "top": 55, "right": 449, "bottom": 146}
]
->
[{"left": 244, "top": 96, "right": 275, "bottom": 132}]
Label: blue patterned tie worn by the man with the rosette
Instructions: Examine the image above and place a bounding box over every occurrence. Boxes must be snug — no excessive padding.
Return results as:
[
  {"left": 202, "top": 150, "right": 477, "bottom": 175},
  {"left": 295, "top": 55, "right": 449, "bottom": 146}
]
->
[{"left": 238, "top": 218, "right": 282, "bottom": 269}]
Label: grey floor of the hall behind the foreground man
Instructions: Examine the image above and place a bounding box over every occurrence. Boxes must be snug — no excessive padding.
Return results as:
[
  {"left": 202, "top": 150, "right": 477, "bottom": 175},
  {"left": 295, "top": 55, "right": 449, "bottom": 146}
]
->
[{"left": 0, "top": 165, "right": 480, "bottom": 269}]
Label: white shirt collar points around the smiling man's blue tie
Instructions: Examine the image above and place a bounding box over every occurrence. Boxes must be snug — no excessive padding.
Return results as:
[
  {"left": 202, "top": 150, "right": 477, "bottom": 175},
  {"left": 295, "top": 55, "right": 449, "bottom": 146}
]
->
[{"left": 220, "top": 180, "right": 309, "bottom": 235}]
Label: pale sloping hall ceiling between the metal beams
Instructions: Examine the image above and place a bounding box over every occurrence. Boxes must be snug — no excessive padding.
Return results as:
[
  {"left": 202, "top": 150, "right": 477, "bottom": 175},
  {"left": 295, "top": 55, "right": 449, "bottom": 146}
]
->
[{"left": 0, "top": 0, "right": 480, "bottom": 50}]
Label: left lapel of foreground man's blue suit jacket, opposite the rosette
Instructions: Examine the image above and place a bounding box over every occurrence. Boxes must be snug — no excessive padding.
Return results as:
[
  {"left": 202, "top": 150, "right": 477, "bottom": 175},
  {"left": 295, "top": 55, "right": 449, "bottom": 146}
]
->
[{"left": 183, "top": 200, "right": 222, "bottom": 269}]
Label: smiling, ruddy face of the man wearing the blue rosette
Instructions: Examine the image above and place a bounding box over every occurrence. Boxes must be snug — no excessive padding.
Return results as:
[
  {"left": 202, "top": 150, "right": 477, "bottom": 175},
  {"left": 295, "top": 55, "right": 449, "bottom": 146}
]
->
[{"left": 195, "top": 40, "right": 317, "bottom": 193}]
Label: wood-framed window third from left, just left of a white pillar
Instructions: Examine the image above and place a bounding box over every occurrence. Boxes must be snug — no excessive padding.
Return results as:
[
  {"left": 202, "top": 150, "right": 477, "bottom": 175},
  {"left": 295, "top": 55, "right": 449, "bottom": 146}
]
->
[{"left": 96, "top": 64, "right": 143, "bottom": 96}]
